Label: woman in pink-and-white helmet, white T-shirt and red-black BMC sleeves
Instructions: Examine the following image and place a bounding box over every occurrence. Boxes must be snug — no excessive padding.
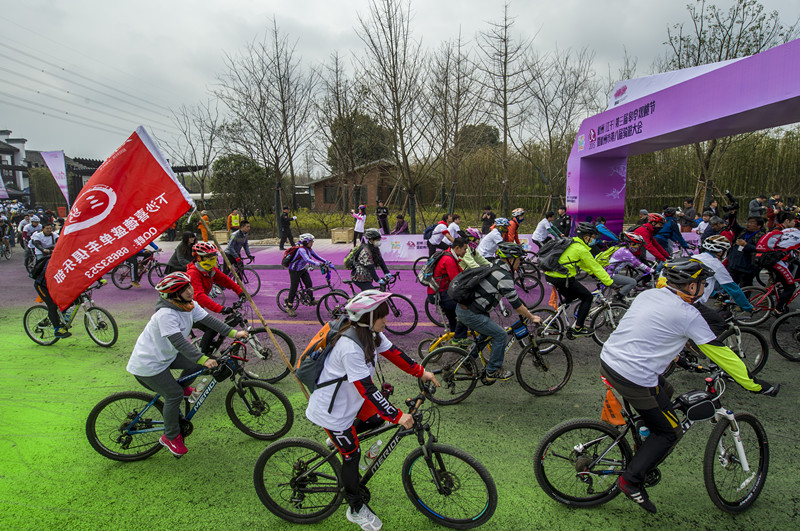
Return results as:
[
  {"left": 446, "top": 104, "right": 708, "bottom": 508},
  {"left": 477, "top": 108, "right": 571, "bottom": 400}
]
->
[{"left": 306, "top": 290, "right": 439, "bottom": 531}]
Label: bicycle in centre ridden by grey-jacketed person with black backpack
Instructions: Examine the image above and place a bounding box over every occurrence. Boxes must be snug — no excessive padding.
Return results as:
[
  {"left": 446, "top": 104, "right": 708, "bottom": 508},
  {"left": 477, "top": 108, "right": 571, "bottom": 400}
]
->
[{"left": 420, "top": 318, "right": 572, "bottom": 405}]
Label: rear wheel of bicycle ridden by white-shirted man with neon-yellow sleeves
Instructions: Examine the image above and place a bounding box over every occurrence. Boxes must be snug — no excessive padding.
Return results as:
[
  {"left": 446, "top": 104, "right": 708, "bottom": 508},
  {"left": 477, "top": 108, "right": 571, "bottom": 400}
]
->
[{"left": 533, "top": 419, "right": 633, "bottom": 507}]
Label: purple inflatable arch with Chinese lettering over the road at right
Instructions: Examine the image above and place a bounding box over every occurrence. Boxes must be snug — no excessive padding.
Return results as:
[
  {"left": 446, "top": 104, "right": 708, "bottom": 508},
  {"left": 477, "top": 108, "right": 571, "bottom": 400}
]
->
[{"left": 566, "top": 39, "right": 800, "bottom": 232}]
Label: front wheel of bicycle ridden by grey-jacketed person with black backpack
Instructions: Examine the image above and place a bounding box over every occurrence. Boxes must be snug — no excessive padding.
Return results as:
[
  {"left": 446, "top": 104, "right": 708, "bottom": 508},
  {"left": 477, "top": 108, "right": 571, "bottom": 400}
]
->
[{"left": 516, "top": 339, "right": 572, "bottom": 396}]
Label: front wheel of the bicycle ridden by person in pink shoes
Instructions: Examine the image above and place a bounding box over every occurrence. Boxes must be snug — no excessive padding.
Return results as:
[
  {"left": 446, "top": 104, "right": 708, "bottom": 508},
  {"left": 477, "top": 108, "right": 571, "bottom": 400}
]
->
[{"left": 225, "top": 380, "right": 294, "bottom": 441}]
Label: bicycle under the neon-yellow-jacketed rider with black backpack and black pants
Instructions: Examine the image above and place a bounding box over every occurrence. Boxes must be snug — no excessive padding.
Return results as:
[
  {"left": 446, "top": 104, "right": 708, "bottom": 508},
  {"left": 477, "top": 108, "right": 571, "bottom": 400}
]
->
[{"left": 533, "top": 284, "right": 628, "bottom": 346}]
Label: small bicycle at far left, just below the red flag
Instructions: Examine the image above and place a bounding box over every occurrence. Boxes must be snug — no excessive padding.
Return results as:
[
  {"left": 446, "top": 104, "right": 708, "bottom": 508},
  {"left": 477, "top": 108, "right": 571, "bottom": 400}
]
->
[{"left": 22, "top": 279, "right": 119, "bottom": 348}]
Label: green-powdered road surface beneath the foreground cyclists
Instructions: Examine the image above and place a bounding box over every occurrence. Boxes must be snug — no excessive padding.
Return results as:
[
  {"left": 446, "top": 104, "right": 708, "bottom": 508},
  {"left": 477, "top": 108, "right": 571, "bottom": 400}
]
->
[{"left": 0, "top": 255, "right": 800, "bottom": 530}]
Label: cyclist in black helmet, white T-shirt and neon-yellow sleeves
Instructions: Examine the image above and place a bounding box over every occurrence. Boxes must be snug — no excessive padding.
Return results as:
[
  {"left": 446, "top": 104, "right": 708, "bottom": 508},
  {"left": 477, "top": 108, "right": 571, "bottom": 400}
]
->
[{"left": 600, "top": 258, "right": 780, "bottom": 513}]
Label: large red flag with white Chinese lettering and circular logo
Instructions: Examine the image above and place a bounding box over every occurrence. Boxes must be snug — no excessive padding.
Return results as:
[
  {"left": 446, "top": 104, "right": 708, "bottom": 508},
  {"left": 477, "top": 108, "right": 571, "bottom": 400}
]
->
[{"left": 47, "top": 126, "right": 194, "bottom": 310}]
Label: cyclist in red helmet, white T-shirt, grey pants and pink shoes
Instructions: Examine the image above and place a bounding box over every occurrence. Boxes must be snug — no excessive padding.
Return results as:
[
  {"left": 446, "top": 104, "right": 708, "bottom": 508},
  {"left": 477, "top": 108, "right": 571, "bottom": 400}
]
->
[{"left": 127, "top": 272, "right": 249, "bottom": 456}]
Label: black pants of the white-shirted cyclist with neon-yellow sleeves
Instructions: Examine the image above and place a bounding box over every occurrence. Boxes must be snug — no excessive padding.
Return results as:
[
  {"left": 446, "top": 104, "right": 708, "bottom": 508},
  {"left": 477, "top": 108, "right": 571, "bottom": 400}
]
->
[{"left": 600, "top": 361, "right": 683, "bottom": 485}]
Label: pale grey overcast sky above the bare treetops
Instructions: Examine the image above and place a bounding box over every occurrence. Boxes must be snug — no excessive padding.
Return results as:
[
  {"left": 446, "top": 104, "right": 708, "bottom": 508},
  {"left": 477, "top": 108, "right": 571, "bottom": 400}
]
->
[{"left": 0, "top": 0, "right": 800, "bottom": 164}]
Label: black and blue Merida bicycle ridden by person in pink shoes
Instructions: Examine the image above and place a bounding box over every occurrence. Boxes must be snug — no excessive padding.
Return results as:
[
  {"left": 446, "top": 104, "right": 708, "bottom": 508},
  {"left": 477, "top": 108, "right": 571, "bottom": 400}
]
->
[{"left": 86, "top": 341, "right": 294, "bottom": 462}]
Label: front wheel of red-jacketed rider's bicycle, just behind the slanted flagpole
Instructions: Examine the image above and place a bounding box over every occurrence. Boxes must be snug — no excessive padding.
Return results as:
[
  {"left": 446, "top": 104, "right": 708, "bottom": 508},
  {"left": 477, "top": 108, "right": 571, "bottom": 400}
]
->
[{"left": 244, "top": 326, "right": 297, "bottom": 383}]
